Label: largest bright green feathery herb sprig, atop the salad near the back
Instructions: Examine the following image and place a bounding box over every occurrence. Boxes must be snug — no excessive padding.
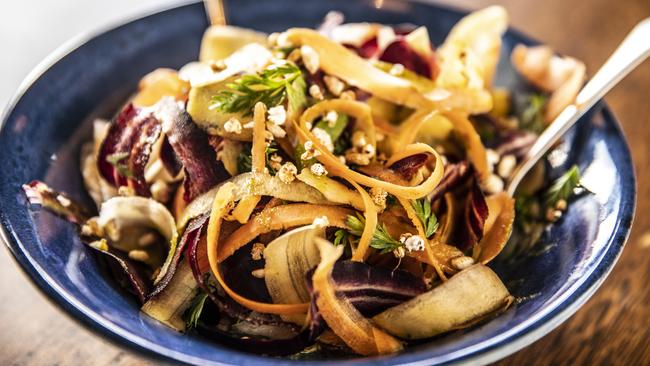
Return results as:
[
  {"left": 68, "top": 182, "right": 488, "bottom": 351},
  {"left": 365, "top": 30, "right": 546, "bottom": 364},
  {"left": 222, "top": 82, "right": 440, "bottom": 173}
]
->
[{"left": 212, "top": 63, "right": 307, "bottom": 116}]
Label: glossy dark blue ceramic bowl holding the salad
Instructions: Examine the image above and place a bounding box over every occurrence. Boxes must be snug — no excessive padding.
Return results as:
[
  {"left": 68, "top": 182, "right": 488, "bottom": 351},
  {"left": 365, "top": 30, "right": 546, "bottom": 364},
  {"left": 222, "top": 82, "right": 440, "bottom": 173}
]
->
[{"left": 0, "top": 0, "right": 635, "bottom": 364}]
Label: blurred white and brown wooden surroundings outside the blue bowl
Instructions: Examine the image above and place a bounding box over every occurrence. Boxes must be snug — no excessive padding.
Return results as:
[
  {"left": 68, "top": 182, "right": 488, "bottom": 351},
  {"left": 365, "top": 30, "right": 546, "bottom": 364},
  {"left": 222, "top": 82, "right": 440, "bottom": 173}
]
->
[{"left": 0, "top": 0, "right": 650, "bottom": 365}]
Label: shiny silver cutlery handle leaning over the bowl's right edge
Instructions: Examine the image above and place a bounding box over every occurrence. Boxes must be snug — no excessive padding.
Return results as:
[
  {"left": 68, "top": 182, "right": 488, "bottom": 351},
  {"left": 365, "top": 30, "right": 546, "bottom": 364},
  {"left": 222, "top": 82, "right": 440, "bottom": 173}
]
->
[{"left": 506, "top": 18, "right": 650, "bottom": 197}]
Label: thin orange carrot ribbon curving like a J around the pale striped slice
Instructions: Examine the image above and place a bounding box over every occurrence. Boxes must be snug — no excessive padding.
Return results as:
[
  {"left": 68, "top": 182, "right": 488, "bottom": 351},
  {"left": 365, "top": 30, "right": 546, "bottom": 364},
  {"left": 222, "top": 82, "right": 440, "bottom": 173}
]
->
[{"left": 207, "top": 182, "right": 309, "bottom": 315}]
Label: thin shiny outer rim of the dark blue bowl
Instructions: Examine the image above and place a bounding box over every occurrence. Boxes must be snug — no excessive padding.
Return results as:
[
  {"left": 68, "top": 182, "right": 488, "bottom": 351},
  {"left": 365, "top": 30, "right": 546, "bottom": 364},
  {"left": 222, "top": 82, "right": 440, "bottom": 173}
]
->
[{"left": 0, "top": 0, "right": 637, "bottom": 364}]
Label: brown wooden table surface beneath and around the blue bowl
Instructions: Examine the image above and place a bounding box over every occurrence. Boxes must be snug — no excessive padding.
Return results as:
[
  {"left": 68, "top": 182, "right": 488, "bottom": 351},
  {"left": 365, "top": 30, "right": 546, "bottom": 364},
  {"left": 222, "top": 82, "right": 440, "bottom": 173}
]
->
[{"left": 0, "top": 0, "right": 650, "bottom": 365}]
